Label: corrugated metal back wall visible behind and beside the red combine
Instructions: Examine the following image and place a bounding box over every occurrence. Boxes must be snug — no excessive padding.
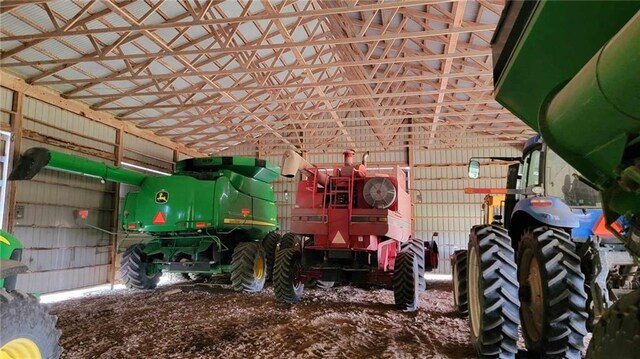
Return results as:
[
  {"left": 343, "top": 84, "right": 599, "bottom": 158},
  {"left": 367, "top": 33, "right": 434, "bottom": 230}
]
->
[{"left": 223, "top": 140, "right": 519, "bottom": 273}]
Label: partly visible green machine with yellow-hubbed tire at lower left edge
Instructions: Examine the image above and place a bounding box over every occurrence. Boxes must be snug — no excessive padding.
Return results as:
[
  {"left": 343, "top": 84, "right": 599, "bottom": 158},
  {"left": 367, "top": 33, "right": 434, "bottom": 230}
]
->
[{"left": 0, "top": 230, "right": 62, "bottom": 359}]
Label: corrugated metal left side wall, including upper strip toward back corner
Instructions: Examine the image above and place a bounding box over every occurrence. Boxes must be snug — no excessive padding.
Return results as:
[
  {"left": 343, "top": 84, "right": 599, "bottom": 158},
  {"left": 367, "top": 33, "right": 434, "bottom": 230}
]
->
[{"left": 0, "top": 87, "right": 180, "bottom": 293}]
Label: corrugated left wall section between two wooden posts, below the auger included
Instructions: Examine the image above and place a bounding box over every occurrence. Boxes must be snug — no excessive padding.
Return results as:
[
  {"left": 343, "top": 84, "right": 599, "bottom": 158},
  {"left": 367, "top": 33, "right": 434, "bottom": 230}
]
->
[{"left": 13, "top": 97, "right": 115, "bottom": 293}]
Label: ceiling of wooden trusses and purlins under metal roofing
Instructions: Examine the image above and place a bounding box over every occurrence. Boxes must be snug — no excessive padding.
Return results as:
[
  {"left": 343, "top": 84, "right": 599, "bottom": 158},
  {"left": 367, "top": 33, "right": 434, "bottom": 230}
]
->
[{"left": 0, "top": 0, "right": 531, "bottom": 153}]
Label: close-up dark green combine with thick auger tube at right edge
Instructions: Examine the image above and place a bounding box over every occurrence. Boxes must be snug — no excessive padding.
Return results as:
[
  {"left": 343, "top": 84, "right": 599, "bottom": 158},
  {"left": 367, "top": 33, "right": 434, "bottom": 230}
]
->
[{"left": 488, "top": 1, "right": 640, "bottom": 358}]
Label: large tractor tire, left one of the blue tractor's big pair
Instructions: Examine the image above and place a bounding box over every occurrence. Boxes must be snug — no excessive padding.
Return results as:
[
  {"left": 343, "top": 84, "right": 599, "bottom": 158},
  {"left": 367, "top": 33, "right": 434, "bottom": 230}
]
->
[{"left": 467, "top": 225, "right": 520, "bottom": 358}]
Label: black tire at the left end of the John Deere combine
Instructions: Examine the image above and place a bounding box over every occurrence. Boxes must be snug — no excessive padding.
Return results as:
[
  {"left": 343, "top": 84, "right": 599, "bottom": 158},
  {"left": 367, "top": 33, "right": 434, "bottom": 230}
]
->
[{"left": 120, "top": 244, "right": 162, "bottom": 289}]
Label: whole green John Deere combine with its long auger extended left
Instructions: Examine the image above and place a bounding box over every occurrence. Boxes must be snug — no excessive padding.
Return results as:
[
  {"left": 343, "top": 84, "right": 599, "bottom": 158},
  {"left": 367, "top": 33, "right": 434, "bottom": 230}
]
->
[{"left": 9, "top": 147, "right": 280, "bottom": 292}]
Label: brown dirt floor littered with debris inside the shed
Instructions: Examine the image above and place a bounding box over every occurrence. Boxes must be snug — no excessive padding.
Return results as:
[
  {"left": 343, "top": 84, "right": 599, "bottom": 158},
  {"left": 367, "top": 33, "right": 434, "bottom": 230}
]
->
[{"left": 51, "top": 280, "right": 475, "bottom": 359}]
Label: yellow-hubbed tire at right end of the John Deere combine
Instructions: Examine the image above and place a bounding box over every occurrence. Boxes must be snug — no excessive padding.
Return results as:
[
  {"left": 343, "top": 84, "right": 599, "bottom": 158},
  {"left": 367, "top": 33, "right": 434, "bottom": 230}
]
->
[{"left": 231, "top": 242, "right": 267, "bottom": 293}]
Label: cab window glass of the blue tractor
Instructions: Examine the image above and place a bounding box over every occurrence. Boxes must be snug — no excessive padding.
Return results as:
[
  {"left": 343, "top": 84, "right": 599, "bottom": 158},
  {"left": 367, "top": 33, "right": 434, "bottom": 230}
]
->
[{"left": 544, "top": 147, "right": 600, "bottom": 207}]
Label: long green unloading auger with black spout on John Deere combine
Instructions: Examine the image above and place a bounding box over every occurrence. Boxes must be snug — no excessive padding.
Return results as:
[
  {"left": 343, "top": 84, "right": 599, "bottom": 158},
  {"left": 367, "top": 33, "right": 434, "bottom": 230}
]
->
[{"left": 9, "top": 147, "right": 146, "bottom": 186}]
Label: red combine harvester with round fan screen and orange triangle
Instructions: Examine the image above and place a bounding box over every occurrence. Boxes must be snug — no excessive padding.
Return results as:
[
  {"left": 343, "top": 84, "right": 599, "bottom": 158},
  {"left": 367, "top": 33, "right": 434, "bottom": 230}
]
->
[{"left": 273, "top": 150, "right": 437, "bottom": 310}]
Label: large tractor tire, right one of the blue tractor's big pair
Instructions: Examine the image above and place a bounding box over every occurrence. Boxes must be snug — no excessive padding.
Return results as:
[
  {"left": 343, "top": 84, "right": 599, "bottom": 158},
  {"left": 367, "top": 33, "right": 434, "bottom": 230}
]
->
[{"left": 518, "top": 226, "right": 587, "bottom": 358}]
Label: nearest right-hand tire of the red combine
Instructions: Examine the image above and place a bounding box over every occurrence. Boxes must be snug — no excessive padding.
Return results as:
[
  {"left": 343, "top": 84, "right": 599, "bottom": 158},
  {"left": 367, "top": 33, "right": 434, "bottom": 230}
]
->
[{"left": 393, "top": 251, "right": 421, "bottom": 311}]
